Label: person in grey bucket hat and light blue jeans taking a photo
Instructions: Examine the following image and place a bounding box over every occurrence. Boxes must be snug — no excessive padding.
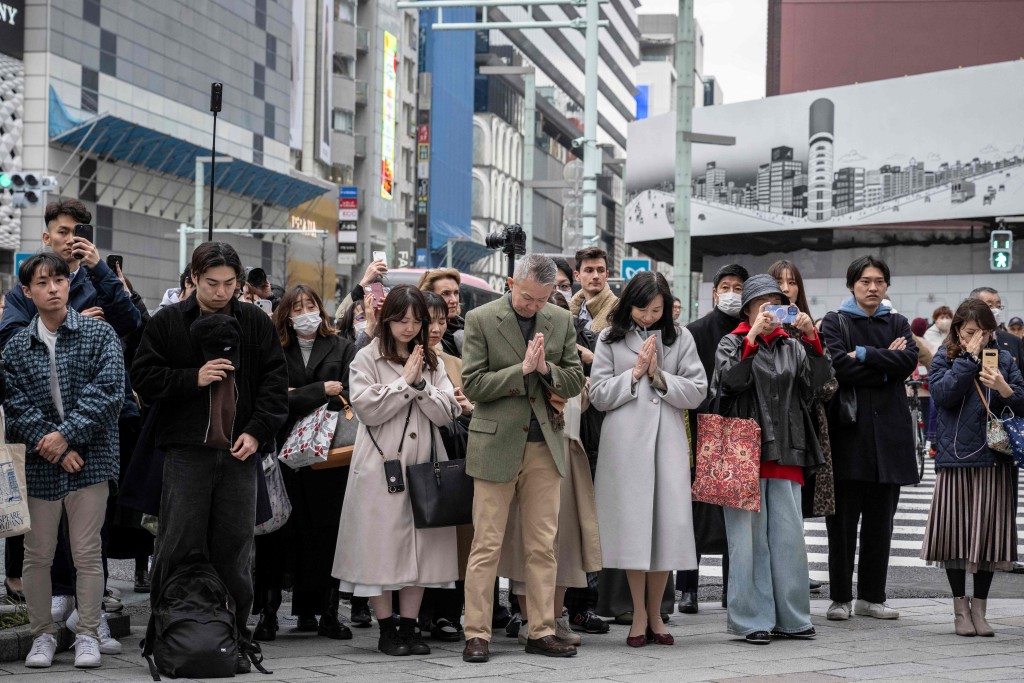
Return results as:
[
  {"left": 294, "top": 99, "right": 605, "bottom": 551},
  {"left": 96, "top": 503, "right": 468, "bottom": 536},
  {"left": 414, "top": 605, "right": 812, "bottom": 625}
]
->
[{"left": 712, "top": 274, "right": 831, "bottom": 645}]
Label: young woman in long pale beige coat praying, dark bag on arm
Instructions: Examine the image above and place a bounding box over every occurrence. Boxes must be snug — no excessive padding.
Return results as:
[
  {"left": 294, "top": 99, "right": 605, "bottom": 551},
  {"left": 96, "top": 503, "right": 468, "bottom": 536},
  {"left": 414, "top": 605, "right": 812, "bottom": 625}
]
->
[{"left": 332, "top": 286, "right": 462, "bottom": 655}]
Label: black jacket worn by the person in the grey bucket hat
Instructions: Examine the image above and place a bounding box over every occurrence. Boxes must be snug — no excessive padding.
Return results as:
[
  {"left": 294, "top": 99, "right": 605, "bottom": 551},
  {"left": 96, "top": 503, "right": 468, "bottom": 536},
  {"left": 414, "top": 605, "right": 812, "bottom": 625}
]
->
[{"left": 711, "top": 325, "right": 833, "bottom": 471}]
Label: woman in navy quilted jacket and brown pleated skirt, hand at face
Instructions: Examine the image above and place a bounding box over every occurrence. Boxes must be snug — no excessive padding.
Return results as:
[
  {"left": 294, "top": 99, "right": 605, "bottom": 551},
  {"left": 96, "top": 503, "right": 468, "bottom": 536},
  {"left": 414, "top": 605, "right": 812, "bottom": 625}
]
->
[{"left": 921, "top": 299, "right": 1024, "bottom": 636}]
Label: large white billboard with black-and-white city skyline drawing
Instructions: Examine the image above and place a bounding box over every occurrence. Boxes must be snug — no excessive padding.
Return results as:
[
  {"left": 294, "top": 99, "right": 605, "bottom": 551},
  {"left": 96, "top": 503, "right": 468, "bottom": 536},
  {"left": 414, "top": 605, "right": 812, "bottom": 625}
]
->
[{"left": 626, "top": 61, "right": 1024, "bottom": 243}]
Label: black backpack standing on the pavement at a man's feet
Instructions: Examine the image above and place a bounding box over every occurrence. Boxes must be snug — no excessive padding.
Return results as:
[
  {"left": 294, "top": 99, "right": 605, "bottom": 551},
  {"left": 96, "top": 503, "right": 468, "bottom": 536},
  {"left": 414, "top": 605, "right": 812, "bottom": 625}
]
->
[{"left": 142, "top": 558, "right": 264, "bottom": 681}]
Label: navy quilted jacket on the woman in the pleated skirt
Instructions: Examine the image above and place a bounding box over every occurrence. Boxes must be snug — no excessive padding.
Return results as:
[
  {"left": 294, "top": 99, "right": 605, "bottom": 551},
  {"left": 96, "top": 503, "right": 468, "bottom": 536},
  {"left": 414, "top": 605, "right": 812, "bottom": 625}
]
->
[{"left": 928, "top": 344, "right": 1024, "bottom": 467}]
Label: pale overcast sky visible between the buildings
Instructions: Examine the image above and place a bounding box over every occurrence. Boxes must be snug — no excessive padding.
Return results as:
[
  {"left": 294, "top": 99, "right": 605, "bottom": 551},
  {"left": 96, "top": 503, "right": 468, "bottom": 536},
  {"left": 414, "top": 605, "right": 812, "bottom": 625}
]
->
[{"left": 640, "top": 0, "right": 768, "bottom": 103}]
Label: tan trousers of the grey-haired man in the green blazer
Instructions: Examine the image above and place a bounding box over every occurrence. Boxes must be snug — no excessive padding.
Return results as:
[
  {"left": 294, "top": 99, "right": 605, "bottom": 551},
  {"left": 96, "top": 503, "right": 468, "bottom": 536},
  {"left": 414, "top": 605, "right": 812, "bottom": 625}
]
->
[{"left": 466, "top": 441, "right": 561, "bottom": 641}]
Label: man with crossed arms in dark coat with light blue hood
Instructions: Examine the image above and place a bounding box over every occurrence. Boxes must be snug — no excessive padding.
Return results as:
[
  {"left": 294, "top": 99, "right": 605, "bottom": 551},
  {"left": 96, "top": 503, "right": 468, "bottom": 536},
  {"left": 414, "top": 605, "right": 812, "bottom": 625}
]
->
[{"left": 821, "top": 256, "right": 919, "bottom": 622}]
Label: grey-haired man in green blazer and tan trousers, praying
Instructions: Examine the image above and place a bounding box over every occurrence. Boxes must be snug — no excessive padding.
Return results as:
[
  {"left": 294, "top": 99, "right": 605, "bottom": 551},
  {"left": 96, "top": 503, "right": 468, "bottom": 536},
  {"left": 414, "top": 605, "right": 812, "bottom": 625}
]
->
[{"left": 462, "top": 254, "right": 584, "bottom": 661}]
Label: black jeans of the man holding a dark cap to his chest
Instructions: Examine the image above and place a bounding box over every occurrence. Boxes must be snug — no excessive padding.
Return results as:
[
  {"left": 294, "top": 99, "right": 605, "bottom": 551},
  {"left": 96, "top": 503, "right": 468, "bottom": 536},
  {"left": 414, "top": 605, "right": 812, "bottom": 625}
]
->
[{"left": 150, "top": 446, "right": 260, "bottom": 640}]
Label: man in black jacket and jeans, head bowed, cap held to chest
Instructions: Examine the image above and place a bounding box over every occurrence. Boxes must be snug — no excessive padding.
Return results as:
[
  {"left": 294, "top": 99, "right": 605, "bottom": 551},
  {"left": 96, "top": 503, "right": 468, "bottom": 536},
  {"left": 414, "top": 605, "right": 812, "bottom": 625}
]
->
[{"left": 131, "top": 242, "right": 288, "bottom": 673}]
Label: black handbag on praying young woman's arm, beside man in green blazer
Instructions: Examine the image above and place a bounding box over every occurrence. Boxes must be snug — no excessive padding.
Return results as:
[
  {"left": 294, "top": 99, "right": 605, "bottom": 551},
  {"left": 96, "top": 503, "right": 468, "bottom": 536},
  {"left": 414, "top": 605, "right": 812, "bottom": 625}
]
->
[{"left": 406, "top": 426, "right": 473, "bottom": 528}]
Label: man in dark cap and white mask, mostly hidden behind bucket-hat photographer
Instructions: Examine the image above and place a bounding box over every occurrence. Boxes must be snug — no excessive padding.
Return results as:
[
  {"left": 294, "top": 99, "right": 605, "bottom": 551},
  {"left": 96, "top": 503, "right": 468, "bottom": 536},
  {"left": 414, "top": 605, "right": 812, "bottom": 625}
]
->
[{"left": 676, "top": 263, "right": 749, "bottom": 614}]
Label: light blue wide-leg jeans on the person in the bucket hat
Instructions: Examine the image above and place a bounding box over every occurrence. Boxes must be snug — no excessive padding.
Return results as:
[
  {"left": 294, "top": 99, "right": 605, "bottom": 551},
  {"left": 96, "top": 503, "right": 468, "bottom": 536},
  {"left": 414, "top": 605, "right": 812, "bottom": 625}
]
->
[{"left": 722, "top": 479, "right": 811, "bottom": 636}]
